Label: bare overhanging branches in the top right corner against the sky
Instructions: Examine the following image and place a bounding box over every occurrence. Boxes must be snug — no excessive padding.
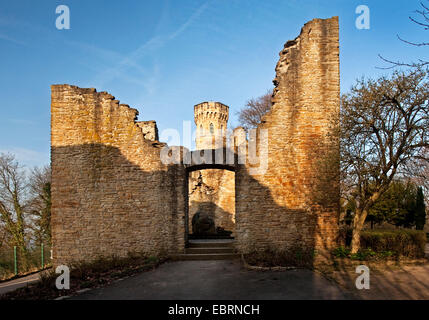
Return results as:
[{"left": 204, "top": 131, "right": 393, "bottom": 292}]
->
[{"left": 378, "top": 2, "right": 429, "bottom": 69}]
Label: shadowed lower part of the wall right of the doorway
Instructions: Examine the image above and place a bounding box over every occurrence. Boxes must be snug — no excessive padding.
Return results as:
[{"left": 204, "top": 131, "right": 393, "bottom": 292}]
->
[{"left": 236, "top": 168, "right": 338, "bottom": 262}]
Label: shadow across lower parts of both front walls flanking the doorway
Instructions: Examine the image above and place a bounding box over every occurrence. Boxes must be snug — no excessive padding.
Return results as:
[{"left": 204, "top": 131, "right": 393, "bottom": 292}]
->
[{"left": 51, "top": 142, "right": 334, "bottom": 264}]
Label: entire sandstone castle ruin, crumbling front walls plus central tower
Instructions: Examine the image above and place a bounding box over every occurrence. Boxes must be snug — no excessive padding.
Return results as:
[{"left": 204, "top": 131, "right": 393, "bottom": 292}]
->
[{"left": 51, "top": 17, "right": 340, "bottom": 265}]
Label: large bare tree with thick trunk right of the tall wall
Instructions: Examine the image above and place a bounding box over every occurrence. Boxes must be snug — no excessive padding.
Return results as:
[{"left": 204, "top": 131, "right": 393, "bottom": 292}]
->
[{"left": 340, "top": 69, "right": 429, "bottom": 253}]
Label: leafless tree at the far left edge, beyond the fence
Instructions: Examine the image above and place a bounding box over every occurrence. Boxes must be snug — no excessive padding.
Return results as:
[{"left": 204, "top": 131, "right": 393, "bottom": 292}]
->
[{"left": 0, "top": 154, "right": 28, "bottom": 265}]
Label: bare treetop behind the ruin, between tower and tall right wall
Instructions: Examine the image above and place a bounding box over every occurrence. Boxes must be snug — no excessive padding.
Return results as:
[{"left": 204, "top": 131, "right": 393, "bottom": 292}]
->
[{"left": 237, "top": 90, "right": 273, "bottom": 130}]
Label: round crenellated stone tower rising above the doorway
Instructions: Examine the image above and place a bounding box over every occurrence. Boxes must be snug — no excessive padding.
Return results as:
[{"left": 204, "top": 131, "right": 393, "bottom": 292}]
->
[{"left": 194, "top": 101, "right": 229, "bottom": 150}]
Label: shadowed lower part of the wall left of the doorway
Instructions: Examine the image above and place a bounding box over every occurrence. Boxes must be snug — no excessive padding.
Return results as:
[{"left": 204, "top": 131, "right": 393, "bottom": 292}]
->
[{"left": 51, "top": 142, "right": 187, "bottom": 264}]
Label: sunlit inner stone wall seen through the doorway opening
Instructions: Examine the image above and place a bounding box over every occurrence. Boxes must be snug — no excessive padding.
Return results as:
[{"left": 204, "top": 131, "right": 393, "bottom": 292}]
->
[{"left": 188, "top": 169, "right": 235, "bottom": 233}]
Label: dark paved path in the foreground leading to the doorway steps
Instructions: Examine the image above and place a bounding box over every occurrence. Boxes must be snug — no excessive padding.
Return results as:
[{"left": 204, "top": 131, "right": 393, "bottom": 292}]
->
[{"left": 73, "top": 260, "right": 351, "bottom": 300}]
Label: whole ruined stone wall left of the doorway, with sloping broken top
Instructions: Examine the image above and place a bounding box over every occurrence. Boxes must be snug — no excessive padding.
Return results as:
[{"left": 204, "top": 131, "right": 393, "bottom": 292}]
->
[{"left": 51, "top": 85, "right": 187, "bottom": 265}]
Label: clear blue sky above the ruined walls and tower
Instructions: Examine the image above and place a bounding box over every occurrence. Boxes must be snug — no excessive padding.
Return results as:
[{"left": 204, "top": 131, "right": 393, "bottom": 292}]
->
[{"left": 0, "top": 0, "right": 428, "bottom": 166}]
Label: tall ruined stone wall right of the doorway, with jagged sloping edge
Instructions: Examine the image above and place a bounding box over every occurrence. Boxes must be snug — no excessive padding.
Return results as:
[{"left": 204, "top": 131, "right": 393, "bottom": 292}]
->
[{"left": 232, "top": 17, "right": 340, "bottom": 258}]
